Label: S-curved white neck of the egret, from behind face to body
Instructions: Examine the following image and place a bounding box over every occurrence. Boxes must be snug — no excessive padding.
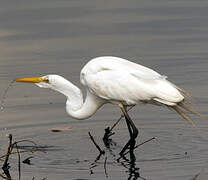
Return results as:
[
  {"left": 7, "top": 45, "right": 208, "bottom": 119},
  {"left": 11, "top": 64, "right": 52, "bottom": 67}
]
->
[{"left": 42, "top": 75, "right": 105, "bottom": 119}]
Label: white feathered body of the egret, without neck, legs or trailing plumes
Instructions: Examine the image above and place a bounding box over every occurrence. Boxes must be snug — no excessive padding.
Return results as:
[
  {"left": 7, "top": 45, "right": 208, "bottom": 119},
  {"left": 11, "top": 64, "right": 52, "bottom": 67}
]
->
[{"left": 80, "top": 57, "right": 184, "bottom": 106}]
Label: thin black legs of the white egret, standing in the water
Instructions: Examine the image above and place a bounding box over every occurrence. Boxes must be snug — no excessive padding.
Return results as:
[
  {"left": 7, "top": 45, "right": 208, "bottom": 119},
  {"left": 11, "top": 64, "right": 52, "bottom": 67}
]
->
[{"left": 120, "top": 104, "right": 138, "bottom": 161}]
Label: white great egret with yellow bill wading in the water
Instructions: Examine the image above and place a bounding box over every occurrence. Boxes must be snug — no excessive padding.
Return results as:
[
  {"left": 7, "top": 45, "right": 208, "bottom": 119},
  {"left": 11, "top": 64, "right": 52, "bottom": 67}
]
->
[{"left": 16, "top": 56, "right": 198, "bottom": 159}]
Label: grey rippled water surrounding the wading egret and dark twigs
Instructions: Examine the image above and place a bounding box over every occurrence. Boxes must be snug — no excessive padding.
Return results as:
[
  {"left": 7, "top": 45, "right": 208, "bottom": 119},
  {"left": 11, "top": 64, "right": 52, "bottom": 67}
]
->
[{"left": 0, "top": 0, "right": 208, "bottom": 180}]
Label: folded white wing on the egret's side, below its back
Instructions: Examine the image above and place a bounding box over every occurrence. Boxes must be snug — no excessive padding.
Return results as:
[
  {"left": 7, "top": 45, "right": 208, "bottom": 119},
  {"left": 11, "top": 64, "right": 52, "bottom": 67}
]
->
[{"left": 81, "top": 70, "right": 158, "bottom": 105}]
